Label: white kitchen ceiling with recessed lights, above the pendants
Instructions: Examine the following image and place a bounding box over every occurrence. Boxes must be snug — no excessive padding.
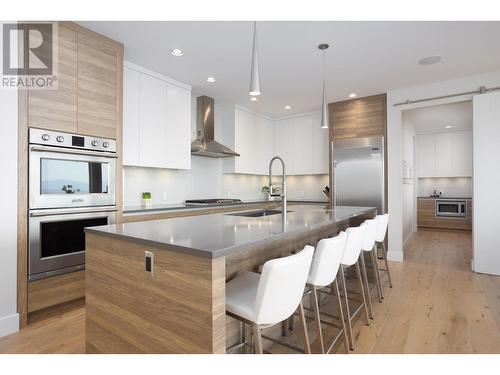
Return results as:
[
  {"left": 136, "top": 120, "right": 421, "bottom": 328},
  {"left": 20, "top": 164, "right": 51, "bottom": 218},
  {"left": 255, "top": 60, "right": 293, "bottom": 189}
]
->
[{"left": 81, "top": 21, "right": 500, "bottom": 117}]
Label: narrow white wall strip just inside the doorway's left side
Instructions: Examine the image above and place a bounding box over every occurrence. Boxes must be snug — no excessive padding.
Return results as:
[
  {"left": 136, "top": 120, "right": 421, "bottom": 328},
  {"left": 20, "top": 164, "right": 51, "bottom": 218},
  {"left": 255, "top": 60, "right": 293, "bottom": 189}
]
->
[{"left": 401, "top": 113, "right": 415, "bottom": 250}]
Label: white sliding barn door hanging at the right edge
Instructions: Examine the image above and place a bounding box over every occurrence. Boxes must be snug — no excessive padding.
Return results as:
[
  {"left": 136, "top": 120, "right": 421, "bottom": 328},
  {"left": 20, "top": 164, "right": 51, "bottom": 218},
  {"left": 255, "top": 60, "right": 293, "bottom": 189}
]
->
[{"left": 472, "top": 92, "right": 500, "bottom": 275}]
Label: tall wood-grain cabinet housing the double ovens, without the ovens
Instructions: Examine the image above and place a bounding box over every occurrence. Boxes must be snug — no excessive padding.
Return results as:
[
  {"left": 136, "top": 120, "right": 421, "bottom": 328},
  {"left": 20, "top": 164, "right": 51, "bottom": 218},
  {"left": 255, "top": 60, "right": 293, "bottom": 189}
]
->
[{"left": 17, "top": 22, "right": 123, "bottom": 327}]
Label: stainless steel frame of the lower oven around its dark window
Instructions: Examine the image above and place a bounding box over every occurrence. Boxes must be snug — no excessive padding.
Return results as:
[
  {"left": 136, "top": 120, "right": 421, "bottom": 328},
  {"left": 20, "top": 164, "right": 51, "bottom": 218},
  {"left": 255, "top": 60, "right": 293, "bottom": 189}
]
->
[{"left": 28, "top": 206, "right": 117, "bottom": 281}]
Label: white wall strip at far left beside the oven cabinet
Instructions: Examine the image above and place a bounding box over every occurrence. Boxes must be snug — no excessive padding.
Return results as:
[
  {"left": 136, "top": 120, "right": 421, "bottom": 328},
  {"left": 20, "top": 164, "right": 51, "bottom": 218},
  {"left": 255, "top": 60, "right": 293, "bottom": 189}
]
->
[{"left": 0, "top": 89, "right": 19, "bottom": 336}]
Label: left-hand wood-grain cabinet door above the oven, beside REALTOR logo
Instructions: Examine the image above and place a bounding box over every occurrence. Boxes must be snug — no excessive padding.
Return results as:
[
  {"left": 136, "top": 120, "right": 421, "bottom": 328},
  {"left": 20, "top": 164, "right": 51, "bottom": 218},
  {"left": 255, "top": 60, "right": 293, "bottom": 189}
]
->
[{"left": 28, "top": 25, "right": 77, "bottom": 133}]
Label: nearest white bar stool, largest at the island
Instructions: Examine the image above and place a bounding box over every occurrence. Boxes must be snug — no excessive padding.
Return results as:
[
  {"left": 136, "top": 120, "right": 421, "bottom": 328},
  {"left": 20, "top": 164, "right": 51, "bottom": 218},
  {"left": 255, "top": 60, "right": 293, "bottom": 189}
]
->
[{"left": 226, "top": 245, "right": 314, "bottom": 354}]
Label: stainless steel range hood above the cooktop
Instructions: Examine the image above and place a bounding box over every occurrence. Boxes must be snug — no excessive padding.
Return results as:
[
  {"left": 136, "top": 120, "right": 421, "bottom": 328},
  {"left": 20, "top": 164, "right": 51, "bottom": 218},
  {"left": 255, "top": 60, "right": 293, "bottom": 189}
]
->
[{"left": 191, "top": 96, "right": 240, "bottom": 158}]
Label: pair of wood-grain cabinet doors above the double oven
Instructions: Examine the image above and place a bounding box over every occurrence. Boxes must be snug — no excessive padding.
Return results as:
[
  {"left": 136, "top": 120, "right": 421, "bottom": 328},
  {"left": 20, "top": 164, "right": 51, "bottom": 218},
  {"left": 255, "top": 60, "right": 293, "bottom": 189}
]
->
[{"left": 27, "top": 22, "right": 123, "bottom": 139}]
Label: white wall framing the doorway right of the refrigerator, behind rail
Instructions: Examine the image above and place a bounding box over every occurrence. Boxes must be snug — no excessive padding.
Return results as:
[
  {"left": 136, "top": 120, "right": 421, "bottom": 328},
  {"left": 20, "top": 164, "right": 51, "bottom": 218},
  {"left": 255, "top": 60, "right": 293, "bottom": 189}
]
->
[{"left": 387, "top": 71, "right": 500, "bottom": 261}]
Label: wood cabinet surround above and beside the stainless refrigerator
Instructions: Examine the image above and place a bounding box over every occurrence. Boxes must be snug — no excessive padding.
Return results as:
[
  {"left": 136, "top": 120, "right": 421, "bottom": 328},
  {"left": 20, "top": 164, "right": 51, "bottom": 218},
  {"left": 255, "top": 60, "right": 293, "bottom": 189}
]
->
[{"left": 328, "top": 94, "right": 388, "bottom": 211}]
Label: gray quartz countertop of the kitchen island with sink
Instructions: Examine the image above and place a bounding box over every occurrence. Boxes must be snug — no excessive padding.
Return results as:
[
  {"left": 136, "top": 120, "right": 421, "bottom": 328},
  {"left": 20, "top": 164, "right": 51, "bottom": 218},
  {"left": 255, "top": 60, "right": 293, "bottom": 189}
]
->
[{"left": 85, "top": 204, "right": 374, "bottom": 258}]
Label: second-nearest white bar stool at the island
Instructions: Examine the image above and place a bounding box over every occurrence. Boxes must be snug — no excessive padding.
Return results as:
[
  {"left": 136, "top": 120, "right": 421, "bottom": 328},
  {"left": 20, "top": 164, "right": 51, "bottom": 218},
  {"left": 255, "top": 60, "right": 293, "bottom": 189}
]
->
[{"left": 307, "top": 232, "right": 349, "bottom": 354}]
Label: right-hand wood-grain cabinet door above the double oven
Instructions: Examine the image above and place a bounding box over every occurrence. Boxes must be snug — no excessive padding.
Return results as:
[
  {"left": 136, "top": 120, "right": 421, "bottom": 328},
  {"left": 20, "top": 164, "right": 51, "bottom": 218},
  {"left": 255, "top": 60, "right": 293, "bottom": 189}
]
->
[{"left": 78, "top": 33, "right": 117, "bottom": 138}]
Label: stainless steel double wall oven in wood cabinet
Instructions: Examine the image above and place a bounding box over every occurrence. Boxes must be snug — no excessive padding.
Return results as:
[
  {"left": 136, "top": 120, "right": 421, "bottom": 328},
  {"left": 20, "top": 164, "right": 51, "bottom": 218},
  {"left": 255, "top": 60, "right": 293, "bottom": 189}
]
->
[{"left": 28, "top": 129, "right": 117, "bottom": 281}]
